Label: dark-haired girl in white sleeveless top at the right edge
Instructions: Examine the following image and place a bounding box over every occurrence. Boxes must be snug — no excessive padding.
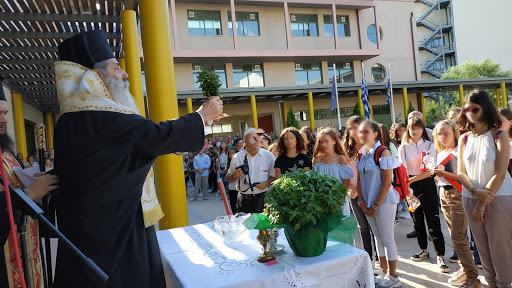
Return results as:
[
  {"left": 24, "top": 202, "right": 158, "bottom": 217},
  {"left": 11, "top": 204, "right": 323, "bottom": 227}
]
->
[{"left": 458, "top": 90, "right": 512, "bottom": 288}]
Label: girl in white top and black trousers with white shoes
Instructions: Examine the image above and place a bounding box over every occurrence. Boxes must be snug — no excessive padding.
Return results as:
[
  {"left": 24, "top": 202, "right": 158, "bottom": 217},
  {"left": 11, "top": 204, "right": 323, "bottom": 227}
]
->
[{"left": 398, "top": 118, "right": 450, "bottom": 273}]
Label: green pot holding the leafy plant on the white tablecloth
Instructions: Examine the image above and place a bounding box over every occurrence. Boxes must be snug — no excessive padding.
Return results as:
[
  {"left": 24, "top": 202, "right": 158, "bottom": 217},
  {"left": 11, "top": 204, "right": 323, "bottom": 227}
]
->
[{"left": 284, "top": 227, "right": 328, "bottom": 257}]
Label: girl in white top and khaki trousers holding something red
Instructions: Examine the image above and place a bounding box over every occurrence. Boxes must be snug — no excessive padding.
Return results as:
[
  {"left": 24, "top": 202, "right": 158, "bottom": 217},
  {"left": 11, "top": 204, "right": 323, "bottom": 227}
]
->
[{"left": 429, "top": 120, "right": 482, "bottom": 288}]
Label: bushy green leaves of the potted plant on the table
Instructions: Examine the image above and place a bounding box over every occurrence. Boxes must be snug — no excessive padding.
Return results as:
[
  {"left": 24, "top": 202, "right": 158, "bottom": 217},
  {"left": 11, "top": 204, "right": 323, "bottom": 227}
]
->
[{"left": 263, "top": 170, "right": 347, "bottom": 230}]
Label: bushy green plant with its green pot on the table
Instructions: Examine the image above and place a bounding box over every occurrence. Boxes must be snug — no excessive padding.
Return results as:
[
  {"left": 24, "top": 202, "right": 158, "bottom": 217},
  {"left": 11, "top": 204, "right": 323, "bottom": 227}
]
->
[{"left": 263, "top": 170, "right": 347, "bottom": 257}]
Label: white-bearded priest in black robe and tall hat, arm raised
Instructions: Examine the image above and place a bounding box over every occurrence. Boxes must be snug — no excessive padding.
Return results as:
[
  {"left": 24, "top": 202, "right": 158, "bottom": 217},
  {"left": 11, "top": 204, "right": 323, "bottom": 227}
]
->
[{"left": 54, "top": 30, "right": 222, "bottom": 288}]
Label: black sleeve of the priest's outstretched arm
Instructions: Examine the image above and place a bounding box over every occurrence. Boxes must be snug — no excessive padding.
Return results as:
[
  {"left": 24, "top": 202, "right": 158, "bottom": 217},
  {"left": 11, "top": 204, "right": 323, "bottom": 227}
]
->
[{"left": 134, "top": 113, "right": 204, "bottom": 157}]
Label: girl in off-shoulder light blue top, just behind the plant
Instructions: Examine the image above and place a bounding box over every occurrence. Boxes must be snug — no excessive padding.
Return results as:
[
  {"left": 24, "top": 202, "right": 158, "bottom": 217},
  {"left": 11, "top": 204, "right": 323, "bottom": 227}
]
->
[{"left": 313, "top": 128, "right": 354, "bottom": 214}]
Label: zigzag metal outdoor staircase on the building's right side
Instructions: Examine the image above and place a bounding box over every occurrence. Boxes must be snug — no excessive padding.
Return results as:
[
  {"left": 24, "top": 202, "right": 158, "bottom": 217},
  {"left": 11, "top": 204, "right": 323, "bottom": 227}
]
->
[{"left": 416, "top": 0, "right": 455, "bottom": 78}]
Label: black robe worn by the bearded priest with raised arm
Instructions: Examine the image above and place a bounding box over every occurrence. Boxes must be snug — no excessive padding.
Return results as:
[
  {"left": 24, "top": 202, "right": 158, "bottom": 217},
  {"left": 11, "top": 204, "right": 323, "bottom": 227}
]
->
[{"left": 53, "top": 111, "right": 204, "bottom": 288}]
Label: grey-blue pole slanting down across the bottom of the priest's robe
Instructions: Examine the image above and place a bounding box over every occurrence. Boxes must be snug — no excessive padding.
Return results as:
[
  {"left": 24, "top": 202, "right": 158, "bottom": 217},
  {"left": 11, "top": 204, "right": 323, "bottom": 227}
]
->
[{"left": 0, "top": 176, "right": 109, "bottom": 283}]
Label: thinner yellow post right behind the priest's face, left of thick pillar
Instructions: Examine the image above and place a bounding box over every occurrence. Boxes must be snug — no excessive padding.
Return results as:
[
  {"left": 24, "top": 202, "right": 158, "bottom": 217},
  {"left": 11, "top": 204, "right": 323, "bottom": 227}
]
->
[{"left": 121, "top": 10, "right": 146, "bottom": 117}]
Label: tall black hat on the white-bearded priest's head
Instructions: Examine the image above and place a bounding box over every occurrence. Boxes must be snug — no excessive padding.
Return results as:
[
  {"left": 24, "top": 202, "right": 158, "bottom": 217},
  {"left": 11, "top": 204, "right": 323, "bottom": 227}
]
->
[{"left": 59, "top": 30, "right": 114, "bottom": 69}]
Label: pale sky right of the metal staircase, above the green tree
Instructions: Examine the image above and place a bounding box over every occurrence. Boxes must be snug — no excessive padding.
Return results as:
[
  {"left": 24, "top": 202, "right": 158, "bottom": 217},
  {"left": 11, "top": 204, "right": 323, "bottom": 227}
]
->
[{"left": 452, "top": 0, "right": 512, "bottom": 70}]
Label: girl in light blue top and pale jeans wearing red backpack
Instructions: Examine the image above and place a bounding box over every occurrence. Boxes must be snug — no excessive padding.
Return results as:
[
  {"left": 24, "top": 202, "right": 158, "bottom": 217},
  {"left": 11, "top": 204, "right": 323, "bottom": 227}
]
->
[{"left": 356, "top": 121, "right": 401, "bottom": 287}]
